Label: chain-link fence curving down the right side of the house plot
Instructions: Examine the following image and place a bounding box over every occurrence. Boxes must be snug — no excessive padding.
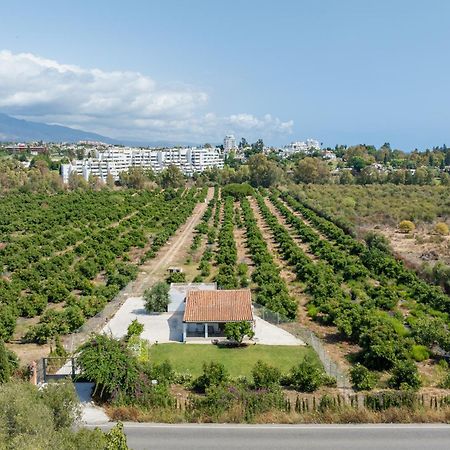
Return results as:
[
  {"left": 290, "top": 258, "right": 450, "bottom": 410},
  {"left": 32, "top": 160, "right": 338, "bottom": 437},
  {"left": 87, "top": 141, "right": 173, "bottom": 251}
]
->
[{"left": 253, "top": 303, "right": 351, "bottom": 389}]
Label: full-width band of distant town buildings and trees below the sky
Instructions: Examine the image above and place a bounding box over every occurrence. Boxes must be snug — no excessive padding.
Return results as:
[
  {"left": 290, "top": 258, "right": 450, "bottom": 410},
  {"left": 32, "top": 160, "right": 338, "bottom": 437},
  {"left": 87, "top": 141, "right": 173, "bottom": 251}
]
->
[{"left": 0, "top": 134, "right": 450, "bottom": 185}]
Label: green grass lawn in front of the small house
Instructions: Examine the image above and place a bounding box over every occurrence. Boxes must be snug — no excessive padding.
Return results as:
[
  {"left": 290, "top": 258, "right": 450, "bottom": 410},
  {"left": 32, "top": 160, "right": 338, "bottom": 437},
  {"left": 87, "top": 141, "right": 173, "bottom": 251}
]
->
[{"left": 150, "top": 344, "right": 321, "bottom": 377}]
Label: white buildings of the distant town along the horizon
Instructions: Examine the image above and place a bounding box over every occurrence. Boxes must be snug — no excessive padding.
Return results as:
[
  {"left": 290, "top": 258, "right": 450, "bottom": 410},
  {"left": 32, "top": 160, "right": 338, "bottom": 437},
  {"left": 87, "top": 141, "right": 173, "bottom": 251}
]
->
[{"left": 3, "top": 135, "right": 324, "bottom": 183}]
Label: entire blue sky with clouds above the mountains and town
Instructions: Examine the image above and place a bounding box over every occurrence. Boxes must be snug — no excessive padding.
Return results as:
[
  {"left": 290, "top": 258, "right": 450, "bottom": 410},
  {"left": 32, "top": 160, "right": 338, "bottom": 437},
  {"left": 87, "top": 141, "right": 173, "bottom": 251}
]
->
[{"left": 0, "top": 0, "right": 450, "bottom": 151}]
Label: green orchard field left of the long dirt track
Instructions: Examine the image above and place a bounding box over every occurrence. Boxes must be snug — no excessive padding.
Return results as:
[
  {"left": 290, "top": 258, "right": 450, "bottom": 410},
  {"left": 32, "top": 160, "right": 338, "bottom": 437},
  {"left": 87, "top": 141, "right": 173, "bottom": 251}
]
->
[{"left": 0, "top": 188, "right": 207, "bottom": 352}]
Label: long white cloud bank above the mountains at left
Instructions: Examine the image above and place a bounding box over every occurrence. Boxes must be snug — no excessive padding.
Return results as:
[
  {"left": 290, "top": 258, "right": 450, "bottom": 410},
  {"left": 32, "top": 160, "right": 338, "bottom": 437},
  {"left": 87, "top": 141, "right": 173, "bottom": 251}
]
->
[{"left": 0, "top": 50, "right": 293, "bottom": 141}]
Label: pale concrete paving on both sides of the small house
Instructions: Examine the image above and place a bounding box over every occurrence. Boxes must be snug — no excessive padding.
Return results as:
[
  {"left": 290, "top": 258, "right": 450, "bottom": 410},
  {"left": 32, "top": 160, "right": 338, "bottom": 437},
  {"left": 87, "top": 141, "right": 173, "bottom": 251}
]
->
[{"left": 103, "top": 297, "right": 305, "bottom": 345}]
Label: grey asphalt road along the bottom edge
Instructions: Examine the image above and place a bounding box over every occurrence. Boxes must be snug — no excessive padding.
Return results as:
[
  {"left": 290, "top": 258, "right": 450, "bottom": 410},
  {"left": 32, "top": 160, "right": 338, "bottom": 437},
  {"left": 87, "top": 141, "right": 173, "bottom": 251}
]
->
[{"left": 91, "top": 423, "right": 450, "bottom": 450}]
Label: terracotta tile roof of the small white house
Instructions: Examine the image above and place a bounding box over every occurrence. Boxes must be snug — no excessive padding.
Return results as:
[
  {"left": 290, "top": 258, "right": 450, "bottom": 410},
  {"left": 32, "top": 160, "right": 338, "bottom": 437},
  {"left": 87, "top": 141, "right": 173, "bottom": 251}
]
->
[{"left": 183, "top": 289, "right": 253, "bottom": 322}]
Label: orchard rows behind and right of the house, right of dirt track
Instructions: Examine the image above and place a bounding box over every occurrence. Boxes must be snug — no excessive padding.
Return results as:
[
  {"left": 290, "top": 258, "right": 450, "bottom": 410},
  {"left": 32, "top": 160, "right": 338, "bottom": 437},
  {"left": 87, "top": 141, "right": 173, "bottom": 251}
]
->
[{"left": 181, "top": 185, "right": 450, "bottom": 388}]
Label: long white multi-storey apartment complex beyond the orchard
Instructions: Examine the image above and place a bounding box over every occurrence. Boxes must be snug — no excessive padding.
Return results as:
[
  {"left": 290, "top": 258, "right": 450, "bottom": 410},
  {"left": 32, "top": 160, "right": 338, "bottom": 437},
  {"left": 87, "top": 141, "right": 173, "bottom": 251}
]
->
[{"left": 61, "top": 147, "right": 224, "bottom": 183}]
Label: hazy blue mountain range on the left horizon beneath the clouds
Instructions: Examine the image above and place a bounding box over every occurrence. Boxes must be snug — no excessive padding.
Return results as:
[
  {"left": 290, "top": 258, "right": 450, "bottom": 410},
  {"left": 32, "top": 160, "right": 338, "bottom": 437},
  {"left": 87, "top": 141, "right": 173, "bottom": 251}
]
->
[{"left": 0, "top": 113, "right": 200, "bottom": 147}]
